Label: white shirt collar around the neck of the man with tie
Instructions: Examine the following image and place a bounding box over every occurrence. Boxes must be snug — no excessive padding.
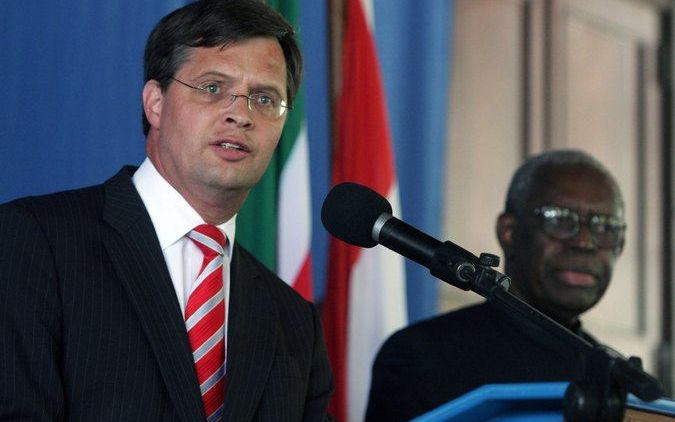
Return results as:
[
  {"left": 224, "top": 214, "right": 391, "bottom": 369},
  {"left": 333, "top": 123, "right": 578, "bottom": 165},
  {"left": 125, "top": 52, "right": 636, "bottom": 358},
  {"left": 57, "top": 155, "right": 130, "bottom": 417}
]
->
[{"left": 132, "top": 157, "right": 237, "bottom": 258}]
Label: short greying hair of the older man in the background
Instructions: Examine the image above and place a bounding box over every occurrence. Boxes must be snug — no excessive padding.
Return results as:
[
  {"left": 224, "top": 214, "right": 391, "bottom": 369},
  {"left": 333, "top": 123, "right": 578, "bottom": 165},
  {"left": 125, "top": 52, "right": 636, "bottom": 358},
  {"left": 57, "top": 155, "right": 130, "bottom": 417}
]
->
[{"left": 504, "top": 149, "right": 623, "bottom": 216}]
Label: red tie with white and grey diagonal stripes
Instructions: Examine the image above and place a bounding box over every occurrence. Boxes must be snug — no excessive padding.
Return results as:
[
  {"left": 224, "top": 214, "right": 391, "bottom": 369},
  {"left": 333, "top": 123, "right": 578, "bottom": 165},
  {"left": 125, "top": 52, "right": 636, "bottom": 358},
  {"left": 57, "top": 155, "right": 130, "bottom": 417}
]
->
[{"left": 185, "top": 224, "right": 227, "bottom": 422}]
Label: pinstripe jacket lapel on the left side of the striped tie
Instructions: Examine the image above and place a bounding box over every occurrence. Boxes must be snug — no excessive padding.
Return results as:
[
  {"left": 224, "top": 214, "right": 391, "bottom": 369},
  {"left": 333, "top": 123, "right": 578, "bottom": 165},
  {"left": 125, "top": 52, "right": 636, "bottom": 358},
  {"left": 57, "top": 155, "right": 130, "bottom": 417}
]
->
[{"left": 103, "top": 168, "right": 204, "bottom": 422}]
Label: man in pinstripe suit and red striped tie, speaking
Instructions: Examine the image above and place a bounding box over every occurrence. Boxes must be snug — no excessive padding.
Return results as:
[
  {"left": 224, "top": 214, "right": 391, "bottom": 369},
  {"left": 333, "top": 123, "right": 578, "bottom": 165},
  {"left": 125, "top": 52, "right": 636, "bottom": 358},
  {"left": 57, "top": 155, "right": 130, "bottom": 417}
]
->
[{"left": 0, "top": 0, "right": 333, "bottom": 422}]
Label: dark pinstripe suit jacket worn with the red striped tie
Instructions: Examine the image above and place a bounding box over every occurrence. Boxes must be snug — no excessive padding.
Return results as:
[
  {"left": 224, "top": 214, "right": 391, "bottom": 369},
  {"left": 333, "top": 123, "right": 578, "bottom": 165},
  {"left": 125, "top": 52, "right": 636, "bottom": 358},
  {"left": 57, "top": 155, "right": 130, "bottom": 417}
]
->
[{"left": 0, "top": 168, "right": 332, "bottom": 421}]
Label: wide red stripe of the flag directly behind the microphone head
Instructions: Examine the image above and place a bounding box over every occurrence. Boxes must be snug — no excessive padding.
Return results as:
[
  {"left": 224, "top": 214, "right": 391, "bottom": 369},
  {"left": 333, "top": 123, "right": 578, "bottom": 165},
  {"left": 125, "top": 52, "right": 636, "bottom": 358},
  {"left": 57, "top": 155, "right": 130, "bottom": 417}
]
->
[{"left": 322, "top": 0, "right": 394, "bottom": 421}]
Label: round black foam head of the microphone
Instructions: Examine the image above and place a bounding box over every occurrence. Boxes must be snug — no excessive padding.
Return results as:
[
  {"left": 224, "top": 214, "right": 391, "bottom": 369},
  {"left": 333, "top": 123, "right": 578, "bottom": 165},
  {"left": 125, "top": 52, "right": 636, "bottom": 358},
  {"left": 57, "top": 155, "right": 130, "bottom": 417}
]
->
[{"left": 321, "top": 182, "right": 391, "bottom": 248}]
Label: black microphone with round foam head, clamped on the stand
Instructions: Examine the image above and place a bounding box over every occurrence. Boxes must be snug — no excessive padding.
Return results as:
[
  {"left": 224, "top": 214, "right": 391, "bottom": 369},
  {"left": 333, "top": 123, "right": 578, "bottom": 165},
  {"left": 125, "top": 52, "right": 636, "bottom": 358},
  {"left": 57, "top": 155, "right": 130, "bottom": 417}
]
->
[{"left": 321, "top": 182, "right": 486, "bottom": 290}]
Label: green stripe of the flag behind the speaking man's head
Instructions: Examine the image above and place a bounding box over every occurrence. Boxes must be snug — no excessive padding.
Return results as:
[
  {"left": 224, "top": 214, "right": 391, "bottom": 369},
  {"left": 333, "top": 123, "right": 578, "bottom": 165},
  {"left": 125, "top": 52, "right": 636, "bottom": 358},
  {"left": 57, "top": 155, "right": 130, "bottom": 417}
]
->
[{"left": 236, "top": 0, "right": 305, "bottom": 271}]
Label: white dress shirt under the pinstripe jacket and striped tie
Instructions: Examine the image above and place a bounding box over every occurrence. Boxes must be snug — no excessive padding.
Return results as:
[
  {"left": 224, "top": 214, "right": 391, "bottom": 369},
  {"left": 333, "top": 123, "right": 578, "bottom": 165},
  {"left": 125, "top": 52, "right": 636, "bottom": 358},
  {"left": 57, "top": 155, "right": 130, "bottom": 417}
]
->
[{"left": 132, "top": 158, "right": 236, "bottom": 332}]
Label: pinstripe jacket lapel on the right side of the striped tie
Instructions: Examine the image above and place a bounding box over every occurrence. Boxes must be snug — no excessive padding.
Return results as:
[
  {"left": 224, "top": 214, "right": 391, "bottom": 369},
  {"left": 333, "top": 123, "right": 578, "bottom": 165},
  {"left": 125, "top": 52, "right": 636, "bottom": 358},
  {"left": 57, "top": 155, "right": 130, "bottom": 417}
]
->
[{"left": 223, "top": 243, "right": 278, "bottom": 421}]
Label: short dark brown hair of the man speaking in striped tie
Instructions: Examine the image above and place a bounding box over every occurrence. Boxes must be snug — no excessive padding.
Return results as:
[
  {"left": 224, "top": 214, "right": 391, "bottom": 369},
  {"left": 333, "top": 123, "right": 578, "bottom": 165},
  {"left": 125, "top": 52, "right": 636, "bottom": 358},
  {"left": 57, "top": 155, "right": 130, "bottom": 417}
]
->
[{"left": 142, "top": 0, "right": 303, "bottom": 135}]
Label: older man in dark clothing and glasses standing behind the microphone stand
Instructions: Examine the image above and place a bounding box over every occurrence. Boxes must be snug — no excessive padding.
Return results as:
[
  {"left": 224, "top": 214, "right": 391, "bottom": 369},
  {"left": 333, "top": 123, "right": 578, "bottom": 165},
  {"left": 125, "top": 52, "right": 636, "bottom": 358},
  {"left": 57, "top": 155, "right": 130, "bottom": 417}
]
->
[{"left": 367, "top": 150, "right": 625, "bottom": 421}]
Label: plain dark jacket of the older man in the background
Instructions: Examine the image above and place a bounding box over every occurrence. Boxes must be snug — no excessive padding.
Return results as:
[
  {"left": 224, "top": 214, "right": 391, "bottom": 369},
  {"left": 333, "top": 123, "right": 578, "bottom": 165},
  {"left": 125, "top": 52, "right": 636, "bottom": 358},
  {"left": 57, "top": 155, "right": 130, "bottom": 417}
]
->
[{"left": 366, "top": 303, "right": 597, "bottom": 421}]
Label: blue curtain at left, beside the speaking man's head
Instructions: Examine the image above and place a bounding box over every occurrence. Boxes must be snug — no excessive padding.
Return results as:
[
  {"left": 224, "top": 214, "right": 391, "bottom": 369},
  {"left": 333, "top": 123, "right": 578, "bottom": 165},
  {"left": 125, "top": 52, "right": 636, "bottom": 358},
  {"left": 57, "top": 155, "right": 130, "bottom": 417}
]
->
[{"left": 0, "top": 0, "right": 189, "bottom": 202}]
